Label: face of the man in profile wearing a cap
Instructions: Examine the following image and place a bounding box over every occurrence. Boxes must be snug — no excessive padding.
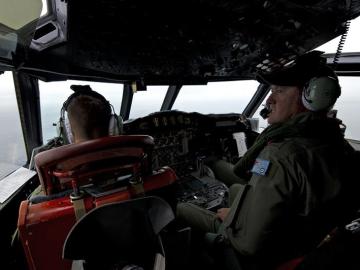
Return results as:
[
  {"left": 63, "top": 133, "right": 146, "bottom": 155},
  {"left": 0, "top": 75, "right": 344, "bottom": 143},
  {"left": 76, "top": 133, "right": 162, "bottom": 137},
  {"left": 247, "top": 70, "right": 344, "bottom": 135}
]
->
[{"left": 266, "top": 85, "right": 304, "bottom": 124}]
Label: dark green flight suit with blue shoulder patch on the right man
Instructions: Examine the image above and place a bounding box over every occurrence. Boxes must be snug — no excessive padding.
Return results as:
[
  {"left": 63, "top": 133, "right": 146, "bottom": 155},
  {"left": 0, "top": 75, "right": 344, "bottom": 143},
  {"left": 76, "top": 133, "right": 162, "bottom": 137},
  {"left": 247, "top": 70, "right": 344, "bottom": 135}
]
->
[{"left": 177, "top": 113, "right": 352, "bottom": 263}]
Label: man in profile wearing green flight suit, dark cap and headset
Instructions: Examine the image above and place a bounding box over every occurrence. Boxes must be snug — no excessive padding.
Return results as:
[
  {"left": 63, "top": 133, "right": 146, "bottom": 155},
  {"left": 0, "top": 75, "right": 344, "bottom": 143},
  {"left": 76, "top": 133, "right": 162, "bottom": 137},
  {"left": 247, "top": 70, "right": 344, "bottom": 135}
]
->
[{"left": 177, "top": 51, "right": 353, "bottom": 269}]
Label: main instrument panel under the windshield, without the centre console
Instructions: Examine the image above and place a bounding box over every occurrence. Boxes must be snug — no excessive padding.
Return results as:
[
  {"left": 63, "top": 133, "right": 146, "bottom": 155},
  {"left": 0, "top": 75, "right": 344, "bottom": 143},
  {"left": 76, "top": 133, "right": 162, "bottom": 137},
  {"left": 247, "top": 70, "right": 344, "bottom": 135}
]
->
[{"left": 124, "top": 111, "right": 250, "bottom": 177}]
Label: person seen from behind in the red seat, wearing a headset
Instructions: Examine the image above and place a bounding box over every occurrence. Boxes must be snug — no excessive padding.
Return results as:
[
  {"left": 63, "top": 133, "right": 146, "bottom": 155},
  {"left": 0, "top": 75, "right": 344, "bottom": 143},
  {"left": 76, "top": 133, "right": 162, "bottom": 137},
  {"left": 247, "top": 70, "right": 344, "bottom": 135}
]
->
[{"left": 31, "top": 85, "right": 120, "bottom": 197}]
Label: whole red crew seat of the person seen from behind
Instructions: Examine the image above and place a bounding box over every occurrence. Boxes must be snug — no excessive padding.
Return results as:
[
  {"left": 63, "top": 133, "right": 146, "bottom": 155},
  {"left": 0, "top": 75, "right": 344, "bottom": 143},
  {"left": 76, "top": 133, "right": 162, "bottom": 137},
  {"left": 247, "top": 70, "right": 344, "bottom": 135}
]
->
[{"left": 18, "top": 135, "right": 177, "bottom": 270}]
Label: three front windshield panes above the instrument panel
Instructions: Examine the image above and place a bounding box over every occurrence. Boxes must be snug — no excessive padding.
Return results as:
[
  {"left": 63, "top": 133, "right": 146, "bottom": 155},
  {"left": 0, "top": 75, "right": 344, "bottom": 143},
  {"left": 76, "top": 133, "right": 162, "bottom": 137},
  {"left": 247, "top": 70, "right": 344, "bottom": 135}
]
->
[{"left": 39, "top": 80, "right": 259, "bottom": 142}]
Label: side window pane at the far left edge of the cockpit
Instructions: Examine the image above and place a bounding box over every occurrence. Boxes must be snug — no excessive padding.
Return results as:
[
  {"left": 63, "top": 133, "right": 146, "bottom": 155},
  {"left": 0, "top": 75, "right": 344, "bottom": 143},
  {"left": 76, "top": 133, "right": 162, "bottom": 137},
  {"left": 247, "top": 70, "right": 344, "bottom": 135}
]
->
[{"left": 0, "top": 71, "right": 27, "bottom": 180}]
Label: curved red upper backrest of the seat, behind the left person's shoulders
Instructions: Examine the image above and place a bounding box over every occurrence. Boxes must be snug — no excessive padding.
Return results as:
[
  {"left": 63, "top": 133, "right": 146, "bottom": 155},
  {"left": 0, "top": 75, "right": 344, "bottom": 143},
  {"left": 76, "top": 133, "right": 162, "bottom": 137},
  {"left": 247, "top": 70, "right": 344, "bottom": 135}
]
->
[{"left": 35, "top": 135, "right": 154, "bottom": 195}]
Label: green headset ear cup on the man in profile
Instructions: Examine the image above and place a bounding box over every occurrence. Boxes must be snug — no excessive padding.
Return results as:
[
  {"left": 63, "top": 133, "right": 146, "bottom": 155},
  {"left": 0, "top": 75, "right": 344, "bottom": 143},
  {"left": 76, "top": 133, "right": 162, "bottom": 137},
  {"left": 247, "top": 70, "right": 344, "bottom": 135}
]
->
[{"left": 302, "top": 76, "right": 341, "bottom": 112}]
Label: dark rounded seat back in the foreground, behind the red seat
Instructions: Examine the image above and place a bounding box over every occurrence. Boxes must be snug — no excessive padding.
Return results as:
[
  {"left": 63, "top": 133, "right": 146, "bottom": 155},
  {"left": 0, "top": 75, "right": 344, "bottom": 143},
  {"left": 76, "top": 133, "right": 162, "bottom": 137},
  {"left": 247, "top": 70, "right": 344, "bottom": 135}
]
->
[{"left": 63, "top": 197, "right": 174, "bottom": 269}]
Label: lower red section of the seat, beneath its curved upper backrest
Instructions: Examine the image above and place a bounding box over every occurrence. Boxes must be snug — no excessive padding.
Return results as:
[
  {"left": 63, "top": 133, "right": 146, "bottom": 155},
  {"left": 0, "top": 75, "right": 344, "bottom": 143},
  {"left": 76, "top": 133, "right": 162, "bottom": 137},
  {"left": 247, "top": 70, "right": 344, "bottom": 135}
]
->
[{"left": 18, "top": 167, "right": 177, "bottom": 270}]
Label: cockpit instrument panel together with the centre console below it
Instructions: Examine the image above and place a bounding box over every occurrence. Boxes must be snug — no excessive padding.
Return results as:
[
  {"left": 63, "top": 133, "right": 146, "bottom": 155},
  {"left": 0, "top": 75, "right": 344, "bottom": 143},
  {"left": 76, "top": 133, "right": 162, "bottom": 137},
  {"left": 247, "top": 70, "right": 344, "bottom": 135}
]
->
[{"left": 124, "top": 111, "right": 256, "bottom": 210}]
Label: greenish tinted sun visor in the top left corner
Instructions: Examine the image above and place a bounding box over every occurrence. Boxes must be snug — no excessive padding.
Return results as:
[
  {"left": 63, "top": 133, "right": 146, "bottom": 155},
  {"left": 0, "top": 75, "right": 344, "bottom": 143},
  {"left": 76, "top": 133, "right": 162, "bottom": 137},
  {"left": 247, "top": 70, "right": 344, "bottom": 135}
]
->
[{"left": 0, "top": 0, "right": 43, "bottom": 60}]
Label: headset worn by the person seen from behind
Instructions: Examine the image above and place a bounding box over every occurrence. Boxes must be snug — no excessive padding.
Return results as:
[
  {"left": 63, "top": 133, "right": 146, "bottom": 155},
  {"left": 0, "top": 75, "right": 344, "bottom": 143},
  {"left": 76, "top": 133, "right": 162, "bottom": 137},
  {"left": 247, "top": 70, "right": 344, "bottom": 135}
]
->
[{"left": 56, "top": 85, "right": 123, "bottom": 144}]
